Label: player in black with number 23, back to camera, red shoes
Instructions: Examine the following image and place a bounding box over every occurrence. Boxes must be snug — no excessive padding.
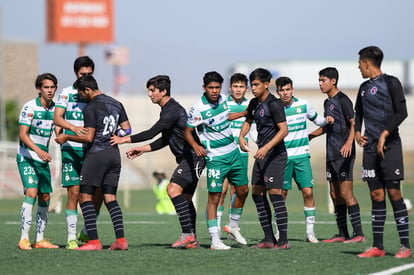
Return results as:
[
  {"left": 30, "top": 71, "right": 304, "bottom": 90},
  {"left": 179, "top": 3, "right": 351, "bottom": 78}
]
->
[{"left": 56, "top": 75, "right": 131, "bottom": 250}]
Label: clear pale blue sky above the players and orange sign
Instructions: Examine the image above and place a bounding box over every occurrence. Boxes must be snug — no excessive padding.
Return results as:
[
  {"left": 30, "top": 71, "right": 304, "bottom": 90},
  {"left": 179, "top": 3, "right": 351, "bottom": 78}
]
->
[{"left": 0, "top": 0, "right": 414, "bottom": 94}]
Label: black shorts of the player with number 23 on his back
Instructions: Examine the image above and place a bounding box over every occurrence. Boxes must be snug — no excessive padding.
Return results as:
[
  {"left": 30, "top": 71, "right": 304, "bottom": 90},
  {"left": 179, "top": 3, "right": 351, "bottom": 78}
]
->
[{"left": 80, "top": 148, "right": 121, "bottom": 191}]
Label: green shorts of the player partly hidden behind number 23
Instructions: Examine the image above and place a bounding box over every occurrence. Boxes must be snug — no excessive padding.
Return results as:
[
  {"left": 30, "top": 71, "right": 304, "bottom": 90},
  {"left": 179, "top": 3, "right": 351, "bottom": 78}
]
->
[{"left": 62, "top": 149, "right": 86, "bottom": 187}]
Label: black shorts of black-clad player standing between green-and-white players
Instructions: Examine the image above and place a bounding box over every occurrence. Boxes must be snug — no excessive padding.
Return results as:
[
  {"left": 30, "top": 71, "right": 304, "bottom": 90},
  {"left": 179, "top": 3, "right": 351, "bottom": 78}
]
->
[{"left": 252, "top": 152, "right": 287, "bottom": 190}]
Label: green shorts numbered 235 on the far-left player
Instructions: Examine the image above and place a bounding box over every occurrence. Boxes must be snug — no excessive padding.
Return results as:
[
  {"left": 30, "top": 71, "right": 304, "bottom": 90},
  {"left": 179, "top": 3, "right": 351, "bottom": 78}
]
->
[{"left": 17, "top": 159, "right": 52, "bottom": 194}]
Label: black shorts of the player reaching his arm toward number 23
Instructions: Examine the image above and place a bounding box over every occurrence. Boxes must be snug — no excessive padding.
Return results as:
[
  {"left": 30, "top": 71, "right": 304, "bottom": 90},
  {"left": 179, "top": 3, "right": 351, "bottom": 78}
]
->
[{"left": 170, "top": 157, "right": 206, "bottom": 195}]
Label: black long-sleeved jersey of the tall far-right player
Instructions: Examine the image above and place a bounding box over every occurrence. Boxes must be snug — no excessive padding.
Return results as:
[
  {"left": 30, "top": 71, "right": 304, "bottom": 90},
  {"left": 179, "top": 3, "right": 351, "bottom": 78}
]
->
[{"left": 355, "top": 74, "right": 407, "bottom": 152}]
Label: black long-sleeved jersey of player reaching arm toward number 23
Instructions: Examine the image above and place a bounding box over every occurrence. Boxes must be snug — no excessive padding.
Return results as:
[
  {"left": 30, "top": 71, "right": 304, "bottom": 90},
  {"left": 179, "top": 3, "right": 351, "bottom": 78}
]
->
[{"left": 131, "top": 97, "right": 199, "bottom": 163}]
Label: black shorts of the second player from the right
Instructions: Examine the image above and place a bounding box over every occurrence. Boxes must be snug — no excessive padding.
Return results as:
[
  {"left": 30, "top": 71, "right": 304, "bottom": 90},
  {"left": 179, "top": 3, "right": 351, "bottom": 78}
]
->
[{"left": 326, "top": 158, "right": 355, "bottom": 182}]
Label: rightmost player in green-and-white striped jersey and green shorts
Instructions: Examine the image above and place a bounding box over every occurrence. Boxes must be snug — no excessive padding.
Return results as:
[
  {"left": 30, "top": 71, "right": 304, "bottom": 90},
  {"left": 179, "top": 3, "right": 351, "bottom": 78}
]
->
[{"left": 276, "top": 76, "right": 327, "bottom": 243}]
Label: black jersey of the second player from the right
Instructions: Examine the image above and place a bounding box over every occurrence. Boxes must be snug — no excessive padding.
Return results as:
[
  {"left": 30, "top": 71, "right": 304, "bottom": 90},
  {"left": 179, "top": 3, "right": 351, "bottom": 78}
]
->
[{"left": 324, "top": 91, "right": 355, "bottom": 161}]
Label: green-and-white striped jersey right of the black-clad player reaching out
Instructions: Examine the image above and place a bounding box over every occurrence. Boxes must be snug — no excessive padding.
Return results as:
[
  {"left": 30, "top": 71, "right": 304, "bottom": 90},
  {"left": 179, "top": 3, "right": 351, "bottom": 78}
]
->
[{"left": 187, "top": 95, "right": 238, "bottom": 160}]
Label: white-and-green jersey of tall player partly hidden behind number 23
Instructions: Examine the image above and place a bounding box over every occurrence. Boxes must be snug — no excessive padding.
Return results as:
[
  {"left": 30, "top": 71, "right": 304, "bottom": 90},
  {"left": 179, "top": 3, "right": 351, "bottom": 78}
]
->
[{"left": 56, "top": 86, "right": 87, "bottom": 150}]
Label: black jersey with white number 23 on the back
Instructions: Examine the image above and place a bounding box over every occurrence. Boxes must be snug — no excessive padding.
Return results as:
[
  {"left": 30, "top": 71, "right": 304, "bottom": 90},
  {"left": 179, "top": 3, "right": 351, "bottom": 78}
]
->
[{"left": 83, "top": 94, "right": 128, "bottom": 153}]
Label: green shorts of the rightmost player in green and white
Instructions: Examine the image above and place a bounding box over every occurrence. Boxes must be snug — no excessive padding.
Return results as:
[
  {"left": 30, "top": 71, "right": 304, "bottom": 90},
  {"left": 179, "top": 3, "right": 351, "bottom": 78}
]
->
[{"left": 283, "top": 157, "right": 313, "bottom": 190}]
